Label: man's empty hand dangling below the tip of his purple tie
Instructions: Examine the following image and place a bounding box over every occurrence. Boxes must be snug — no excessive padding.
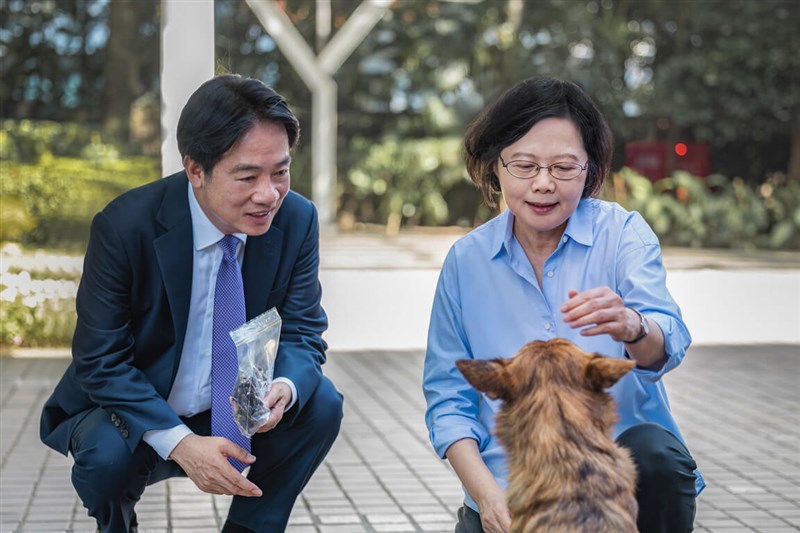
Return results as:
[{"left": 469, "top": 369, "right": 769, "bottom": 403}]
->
[{"left": 169, "top": 434, "right": 261, "bottom": 496}]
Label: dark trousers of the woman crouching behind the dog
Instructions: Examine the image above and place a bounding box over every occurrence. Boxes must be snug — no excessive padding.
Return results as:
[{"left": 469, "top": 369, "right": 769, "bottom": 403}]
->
[{"left": 455, "top": 424, "right": 697, "bottom": 533}]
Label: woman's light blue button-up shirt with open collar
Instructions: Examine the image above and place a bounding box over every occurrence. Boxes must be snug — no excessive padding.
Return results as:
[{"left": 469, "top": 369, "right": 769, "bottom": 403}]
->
[{"left": 423, "top": 198, "right": 705, "bottom": 511}]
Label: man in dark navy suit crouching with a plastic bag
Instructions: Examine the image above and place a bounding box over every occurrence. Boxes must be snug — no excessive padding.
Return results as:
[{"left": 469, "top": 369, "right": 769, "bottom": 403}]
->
[{"left": 41, "top": 76, "right": 342, "bottom": 532}]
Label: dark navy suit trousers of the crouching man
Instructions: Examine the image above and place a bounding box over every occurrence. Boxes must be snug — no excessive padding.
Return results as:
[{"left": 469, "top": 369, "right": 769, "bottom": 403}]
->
[{"left": 71, "top": 377, "right": 342, "bottom": 532}]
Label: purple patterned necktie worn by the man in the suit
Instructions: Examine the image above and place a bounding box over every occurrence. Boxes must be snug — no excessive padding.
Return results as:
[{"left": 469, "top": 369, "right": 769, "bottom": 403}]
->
[{"left": 211, "top": 235, "right": 250, "bottom": 472}]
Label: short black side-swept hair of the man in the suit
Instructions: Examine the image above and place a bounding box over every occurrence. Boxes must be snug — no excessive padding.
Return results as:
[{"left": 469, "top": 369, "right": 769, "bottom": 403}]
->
[{"left": 177, "top": 74, "right": 300, "bottom": 176}]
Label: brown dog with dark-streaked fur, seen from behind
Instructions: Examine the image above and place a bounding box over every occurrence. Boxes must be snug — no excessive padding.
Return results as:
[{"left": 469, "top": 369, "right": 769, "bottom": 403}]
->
[{"left": 456, "top": 339, "right": 638, "bottom": 533}]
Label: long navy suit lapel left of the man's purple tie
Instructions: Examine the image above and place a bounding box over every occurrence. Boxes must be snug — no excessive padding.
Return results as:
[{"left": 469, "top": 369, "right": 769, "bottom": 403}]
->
[{"left": 153, "top": 172, "right": 194, "bottom": 368}]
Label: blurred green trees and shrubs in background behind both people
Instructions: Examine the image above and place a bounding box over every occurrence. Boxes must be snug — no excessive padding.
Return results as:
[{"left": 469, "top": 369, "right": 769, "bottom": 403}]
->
[{"left": 0, "top": 0, "right": 800, "bottom": 247}]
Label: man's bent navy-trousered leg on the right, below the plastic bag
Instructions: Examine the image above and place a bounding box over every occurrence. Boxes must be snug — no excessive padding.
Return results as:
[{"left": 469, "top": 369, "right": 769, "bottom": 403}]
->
[{"left": 223, "top": 377, "right": 343, "bottom": 533}]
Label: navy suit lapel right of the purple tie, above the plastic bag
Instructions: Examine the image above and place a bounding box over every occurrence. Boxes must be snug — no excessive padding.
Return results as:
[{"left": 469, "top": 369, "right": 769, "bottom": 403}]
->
[{"left": 242, "top": 225, "right": 283, "bottom": 320}]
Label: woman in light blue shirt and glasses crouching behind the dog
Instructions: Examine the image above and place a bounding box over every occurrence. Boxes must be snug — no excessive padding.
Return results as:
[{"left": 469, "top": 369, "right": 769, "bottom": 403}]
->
[{"left": 423, "top": 78, "right": 704, "bottom": 533}]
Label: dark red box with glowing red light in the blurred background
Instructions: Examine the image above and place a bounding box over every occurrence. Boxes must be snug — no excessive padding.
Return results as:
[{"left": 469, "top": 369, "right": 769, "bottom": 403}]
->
[{"left": 625, "top": 141, "right": 711, "bottom": 181}]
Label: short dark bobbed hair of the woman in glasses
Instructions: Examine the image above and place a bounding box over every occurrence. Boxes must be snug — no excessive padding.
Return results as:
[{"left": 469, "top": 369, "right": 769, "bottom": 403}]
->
[{"left": 464, "top": 78, "right": 614, "bottom": 206}]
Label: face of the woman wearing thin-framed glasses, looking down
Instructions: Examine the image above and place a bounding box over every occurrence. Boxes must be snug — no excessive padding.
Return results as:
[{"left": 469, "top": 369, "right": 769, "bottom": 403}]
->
[{"left": 496, "top": 117, "right": 589, "bottom": 241}]
